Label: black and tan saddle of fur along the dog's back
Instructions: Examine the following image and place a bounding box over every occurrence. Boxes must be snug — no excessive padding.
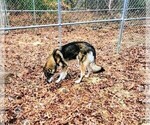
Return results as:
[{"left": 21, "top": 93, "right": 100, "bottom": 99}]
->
[{"left": 60, "top": 41, "right": 96, "bottom": 60}]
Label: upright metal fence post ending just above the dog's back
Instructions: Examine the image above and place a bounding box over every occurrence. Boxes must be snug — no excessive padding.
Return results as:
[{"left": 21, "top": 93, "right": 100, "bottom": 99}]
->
[{"left": 58, "top": 0, "right": 62, "bottom": 48}]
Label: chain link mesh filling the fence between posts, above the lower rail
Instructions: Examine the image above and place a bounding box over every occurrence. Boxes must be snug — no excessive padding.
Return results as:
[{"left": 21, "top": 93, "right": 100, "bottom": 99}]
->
[{"left": 5, "top": 0, "right": 147, "bottom": 27}]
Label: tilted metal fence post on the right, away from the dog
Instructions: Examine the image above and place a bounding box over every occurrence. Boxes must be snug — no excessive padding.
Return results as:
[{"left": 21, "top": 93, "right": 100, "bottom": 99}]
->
[{"left": 117, "top": 0, "right": 128, "bottom": 53}]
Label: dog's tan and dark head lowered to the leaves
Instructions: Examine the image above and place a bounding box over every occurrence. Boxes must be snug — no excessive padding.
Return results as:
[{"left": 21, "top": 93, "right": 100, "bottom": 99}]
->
[{"left": 43, "top": 54, "right": 57, "bottom": 83}]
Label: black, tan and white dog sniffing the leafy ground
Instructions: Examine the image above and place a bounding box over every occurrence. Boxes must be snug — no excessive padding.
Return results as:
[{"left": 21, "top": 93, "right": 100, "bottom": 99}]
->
[{"left": 43, "top": 41, "right": 104, "bottom": 83}]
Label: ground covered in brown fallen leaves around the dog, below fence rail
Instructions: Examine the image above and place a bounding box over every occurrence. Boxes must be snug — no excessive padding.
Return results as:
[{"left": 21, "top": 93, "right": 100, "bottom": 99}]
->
[{"left": 2, "top": 25, "right": 146, "bottom": 125}]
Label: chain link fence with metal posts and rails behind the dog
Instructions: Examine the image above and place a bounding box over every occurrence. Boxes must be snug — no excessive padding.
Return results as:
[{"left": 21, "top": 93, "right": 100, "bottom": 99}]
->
[{"left": 0, "top": 0, "right": 150, "bottom": 52}]
